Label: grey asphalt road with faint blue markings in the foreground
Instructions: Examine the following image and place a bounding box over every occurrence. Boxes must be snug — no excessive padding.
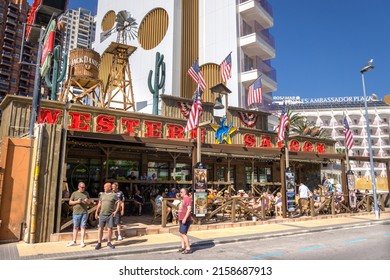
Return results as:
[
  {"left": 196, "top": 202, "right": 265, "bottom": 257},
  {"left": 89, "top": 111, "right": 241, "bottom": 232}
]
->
[{"left": 94, "top": 223, "right": 390, "bottom": 260}]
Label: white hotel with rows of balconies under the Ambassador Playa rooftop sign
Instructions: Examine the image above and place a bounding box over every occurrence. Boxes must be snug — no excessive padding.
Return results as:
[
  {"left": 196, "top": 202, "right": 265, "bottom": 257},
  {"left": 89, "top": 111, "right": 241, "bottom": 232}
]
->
[{"left": 273, "top": 96, "right": 390, "bottom": 188}]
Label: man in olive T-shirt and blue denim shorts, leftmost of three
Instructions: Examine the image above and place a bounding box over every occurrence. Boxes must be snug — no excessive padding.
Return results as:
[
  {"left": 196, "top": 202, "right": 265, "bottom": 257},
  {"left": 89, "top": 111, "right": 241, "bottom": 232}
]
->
[{"left": 66, "top": 182, "right": 91, "bottom": 248}]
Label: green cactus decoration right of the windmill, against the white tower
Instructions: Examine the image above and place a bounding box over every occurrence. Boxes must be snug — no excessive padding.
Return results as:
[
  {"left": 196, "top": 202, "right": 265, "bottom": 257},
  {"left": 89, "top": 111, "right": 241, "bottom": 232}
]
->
[{"left": 148, "top": 52, "right": 165, "bottom": 115}]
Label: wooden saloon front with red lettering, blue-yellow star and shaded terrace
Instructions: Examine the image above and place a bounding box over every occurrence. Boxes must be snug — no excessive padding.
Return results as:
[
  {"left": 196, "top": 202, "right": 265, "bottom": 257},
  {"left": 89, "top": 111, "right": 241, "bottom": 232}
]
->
[{"left": 1, "top": 96, "right": 340, "bottom": 242}]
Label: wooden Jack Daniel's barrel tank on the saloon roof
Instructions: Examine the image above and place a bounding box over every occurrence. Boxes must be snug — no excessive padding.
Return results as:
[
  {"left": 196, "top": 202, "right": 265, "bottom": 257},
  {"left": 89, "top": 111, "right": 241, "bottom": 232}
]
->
[{"left": 69, "top": 48, "right": 100, "bottom": 86}]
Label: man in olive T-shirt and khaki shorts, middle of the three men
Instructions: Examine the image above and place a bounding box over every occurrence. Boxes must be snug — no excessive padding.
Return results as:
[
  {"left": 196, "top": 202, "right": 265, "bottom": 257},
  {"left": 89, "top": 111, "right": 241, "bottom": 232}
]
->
[{"left": 95, "top": 182, "right": 120, "bottom": 250}]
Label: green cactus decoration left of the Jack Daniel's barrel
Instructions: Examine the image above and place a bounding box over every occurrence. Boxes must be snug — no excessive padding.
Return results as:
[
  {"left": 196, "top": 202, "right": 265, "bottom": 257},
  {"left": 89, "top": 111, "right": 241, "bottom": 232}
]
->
[{"left": 45, "top": 46, "right": 68, "bottom": 100}]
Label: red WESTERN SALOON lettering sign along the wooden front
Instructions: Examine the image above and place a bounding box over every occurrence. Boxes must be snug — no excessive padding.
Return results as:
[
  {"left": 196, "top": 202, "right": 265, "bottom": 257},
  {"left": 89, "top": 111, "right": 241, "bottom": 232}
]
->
[{"left": 38, "top": 108, "right": 326, "bottom": 153}]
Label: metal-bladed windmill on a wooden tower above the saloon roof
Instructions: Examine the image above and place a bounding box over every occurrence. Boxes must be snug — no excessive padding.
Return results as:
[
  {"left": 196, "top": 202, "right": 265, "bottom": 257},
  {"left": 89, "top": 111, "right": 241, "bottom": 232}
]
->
[{"left": 99, "top": 10, "right": 138, "bottom": 111}]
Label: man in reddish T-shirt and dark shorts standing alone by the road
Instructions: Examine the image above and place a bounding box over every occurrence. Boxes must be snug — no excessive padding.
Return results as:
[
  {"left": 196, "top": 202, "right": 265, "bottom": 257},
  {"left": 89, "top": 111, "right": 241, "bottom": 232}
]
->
[{"left": 178, "top": 188, "right": 192, "bottom": 254}]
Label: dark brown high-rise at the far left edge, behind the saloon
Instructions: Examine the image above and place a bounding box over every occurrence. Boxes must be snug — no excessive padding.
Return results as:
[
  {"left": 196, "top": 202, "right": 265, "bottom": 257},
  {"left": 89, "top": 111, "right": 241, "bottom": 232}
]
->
[{"left": 0, "top": 0, "right": 37, "bottom": 101}]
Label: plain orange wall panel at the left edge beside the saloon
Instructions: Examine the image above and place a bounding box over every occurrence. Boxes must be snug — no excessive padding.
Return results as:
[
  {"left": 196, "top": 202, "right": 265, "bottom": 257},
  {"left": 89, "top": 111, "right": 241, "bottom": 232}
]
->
[{"left": 0, "top": 137, "right": 32, "bottom": 241}]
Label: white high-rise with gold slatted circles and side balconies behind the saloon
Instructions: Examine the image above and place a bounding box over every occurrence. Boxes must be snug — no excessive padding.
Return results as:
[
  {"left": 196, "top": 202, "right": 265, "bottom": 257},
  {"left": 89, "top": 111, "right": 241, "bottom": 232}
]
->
[{"left": 94, "top": 0, "right": 277, "bottom": 115}]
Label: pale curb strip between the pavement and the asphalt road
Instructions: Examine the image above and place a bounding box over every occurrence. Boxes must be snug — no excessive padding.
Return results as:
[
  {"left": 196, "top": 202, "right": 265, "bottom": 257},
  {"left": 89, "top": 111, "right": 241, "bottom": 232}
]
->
[{"left": 49, "top": 219, "right": 390, "bottom": 260}]
